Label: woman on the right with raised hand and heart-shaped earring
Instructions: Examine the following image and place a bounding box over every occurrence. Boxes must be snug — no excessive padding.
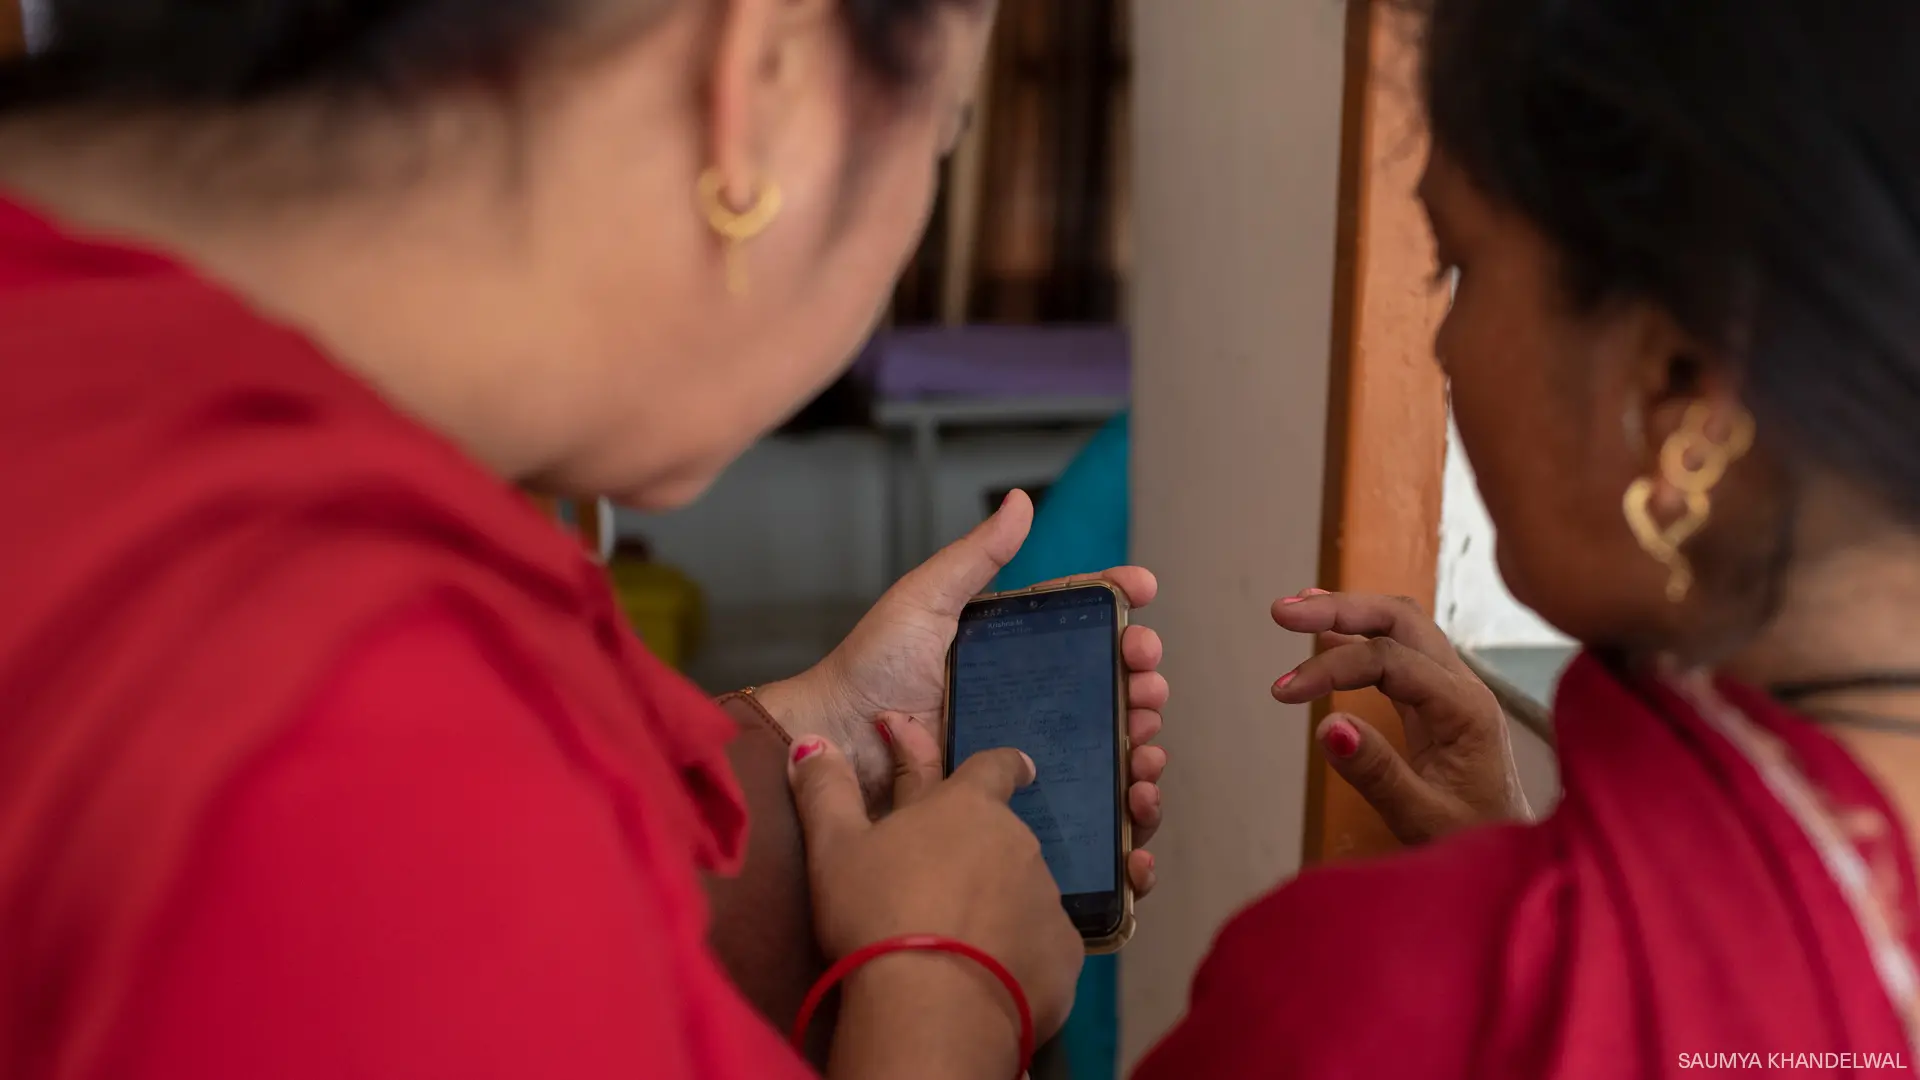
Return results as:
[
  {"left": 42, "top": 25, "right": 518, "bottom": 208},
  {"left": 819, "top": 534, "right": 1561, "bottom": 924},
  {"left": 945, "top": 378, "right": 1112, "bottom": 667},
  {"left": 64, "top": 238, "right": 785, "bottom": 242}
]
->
[{"left": 1137, "top": 0, "right": 1920, "bottom": 1080}]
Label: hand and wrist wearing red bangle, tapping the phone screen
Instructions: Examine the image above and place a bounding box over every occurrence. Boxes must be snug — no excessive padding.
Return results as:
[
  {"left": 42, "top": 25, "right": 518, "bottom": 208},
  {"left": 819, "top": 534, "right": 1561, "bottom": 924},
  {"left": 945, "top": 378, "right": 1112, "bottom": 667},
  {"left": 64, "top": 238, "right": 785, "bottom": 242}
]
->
[{"left": 791, "top": 715, "right": 1083, "bottom": 1080}]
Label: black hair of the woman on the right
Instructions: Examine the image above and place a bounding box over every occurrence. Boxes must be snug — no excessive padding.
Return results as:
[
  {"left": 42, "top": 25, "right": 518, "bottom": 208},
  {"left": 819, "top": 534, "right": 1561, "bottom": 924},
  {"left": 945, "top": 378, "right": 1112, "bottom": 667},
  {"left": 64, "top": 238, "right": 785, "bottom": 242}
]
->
[{"left": 1421, "top": 0, "right": 1920, "bottom": 517}]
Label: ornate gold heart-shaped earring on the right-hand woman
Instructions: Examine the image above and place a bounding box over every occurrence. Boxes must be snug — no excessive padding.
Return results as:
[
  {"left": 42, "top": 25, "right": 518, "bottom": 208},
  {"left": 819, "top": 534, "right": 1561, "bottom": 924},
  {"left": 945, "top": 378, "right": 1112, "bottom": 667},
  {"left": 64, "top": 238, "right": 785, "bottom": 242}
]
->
[{"left": 1620, "top": 402, "right": 1753, "bottom": 603}]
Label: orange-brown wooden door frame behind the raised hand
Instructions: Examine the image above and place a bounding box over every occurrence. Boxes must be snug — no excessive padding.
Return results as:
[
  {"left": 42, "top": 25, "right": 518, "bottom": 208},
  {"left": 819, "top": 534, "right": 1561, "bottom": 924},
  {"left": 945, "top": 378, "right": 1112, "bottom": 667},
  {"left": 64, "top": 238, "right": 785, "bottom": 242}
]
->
[{"left": 1302, "top": 0, "right": 1448, "bottom": 865}]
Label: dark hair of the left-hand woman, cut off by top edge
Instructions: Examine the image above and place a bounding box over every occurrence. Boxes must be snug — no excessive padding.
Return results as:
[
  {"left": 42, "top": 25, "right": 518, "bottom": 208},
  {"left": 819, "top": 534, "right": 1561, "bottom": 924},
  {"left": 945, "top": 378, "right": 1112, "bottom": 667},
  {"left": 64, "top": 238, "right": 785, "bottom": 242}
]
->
[{"left": 0, "top": 0, "right": 973, "bottom": 111}]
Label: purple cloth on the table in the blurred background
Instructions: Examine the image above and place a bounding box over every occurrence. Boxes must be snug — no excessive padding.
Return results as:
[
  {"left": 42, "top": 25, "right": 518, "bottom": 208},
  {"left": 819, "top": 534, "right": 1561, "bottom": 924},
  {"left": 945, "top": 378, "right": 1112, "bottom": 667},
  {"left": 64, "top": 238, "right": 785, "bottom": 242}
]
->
[{"left": 854, "top": 327, "right": 1131, "bottom": 402}]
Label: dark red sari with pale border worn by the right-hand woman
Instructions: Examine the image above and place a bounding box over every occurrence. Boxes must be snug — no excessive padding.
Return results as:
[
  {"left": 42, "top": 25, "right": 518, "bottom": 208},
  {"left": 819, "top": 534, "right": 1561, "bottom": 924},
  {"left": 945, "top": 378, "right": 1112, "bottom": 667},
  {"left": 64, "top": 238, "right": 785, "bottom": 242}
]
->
[{"left": 1135, "top": 657, "right": 1920, "bottom": 1080}]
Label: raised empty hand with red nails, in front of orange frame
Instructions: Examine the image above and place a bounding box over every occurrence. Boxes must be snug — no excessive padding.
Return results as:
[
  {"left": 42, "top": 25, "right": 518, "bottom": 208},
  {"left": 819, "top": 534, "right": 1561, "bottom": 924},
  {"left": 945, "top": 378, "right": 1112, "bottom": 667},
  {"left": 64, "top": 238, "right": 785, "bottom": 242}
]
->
[{"left": 1273, "top": 588, "right": 1532, "bottom": 844}]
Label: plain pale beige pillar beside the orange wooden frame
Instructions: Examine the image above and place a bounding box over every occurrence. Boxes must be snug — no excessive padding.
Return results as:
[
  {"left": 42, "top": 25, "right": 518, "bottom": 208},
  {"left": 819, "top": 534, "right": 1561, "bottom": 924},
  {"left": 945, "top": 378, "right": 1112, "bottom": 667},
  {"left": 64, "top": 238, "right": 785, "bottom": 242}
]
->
[{"left": 1121, "top": 0, "right": 1346, "bottom": 1065}]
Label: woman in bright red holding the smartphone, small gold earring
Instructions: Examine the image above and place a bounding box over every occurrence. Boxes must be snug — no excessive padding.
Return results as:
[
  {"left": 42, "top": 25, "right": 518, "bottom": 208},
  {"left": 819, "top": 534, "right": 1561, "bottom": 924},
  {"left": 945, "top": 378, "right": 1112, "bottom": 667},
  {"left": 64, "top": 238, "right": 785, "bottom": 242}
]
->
[{"left": 0, "top": 0, "right": 1167, "bottom": 1080}]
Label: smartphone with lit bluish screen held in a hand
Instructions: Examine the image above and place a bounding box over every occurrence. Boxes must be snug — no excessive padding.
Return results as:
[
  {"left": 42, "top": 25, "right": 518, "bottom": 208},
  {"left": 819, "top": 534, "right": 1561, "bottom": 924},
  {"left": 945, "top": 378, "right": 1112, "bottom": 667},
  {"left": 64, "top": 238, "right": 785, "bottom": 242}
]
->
[{"left": 947, "top": 582, "right": 1133, "bottom": 953}]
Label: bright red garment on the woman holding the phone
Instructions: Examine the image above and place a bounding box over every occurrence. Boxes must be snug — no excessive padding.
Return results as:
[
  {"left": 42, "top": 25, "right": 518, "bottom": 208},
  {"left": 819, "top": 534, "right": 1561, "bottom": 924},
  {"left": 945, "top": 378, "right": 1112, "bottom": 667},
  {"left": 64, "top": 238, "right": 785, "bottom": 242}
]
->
[{"left": 0, "top": 202, "right": 808, "bottom": 1080}]
